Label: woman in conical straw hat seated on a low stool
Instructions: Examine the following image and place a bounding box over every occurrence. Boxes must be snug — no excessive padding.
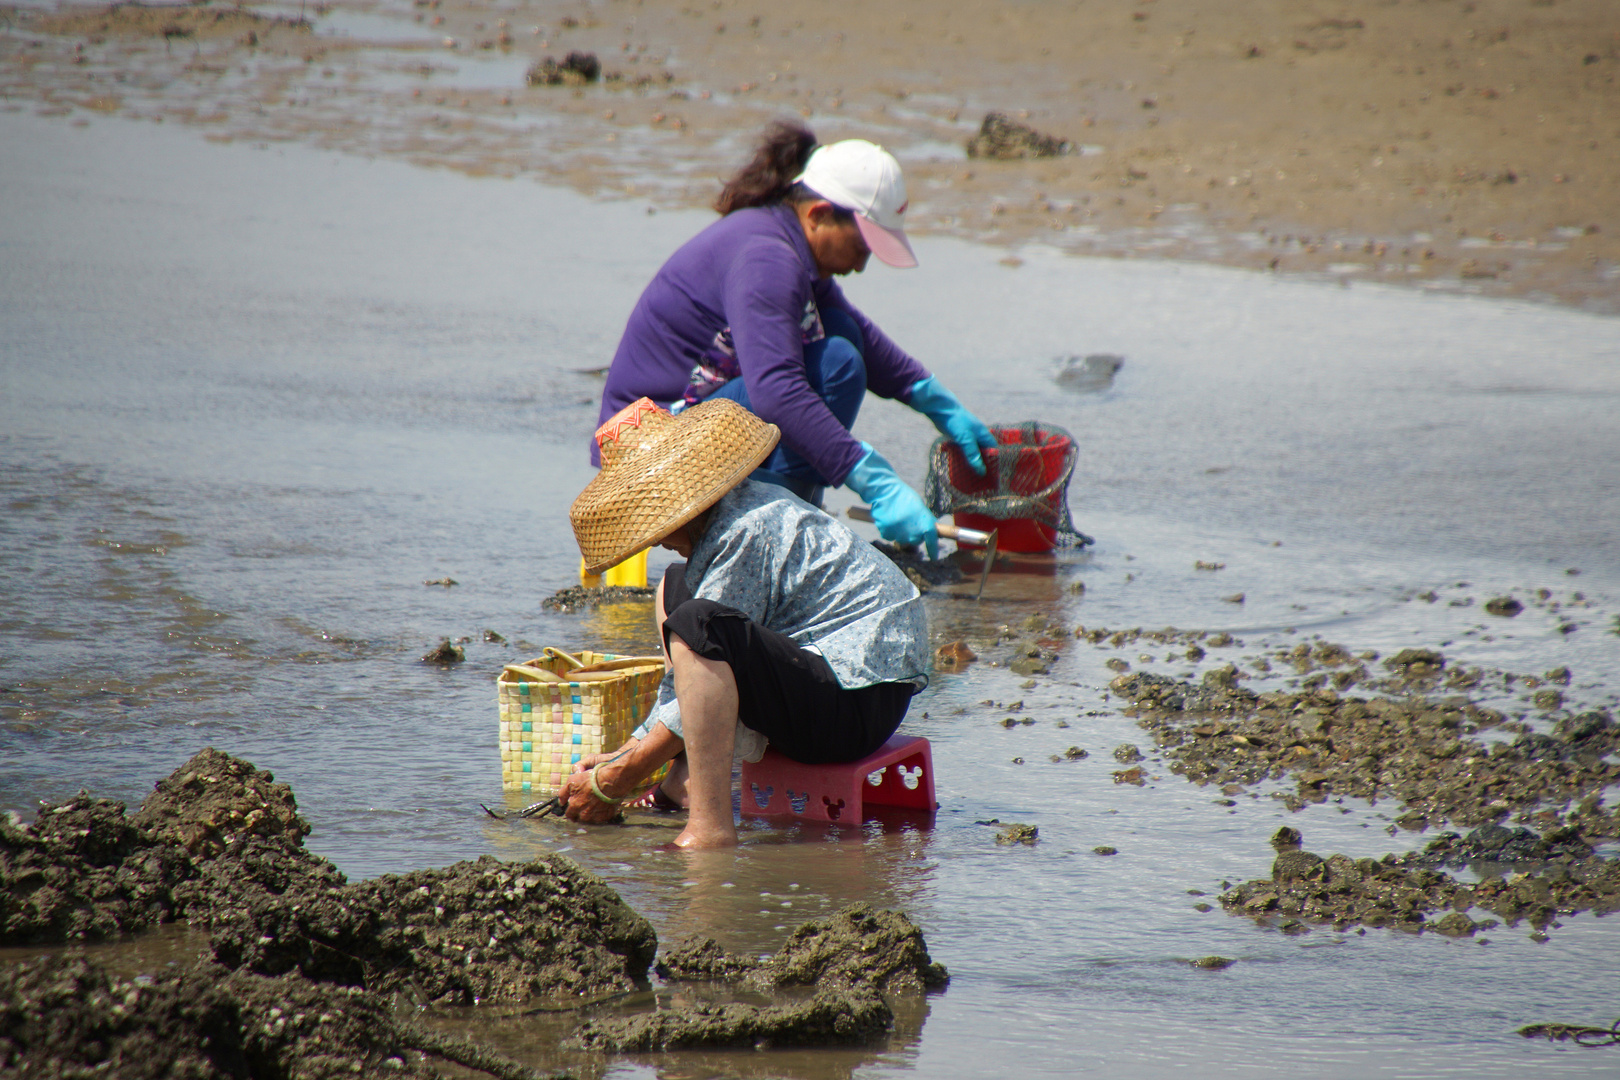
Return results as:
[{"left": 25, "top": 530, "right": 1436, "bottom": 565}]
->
[{"left": 561, "top": 398, "right": 928, "bottom": 847}]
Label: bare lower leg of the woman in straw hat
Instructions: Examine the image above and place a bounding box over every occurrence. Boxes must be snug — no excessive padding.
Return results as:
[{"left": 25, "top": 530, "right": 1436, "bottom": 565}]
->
[{"left": 669, "top": 635, "right": 737, "bottom": 847}]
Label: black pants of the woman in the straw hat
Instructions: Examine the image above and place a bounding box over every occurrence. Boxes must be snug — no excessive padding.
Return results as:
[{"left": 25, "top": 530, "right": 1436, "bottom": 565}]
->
[{"left": 664, "top": 562, "right": 915, "bottom": 764}]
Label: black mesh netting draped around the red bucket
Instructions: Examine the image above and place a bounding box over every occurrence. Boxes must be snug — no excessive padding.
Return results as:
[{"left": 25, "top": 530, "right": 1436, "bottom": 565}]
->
[{"left": 923, "top": 421, "right": 1092, "bottom": 544}]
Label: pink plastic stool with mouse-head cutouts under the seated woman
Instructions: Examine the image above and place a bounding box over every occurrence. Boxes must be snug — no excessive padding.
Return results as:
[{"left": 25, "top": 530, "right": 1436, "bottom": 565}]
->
[{"left": 742, "top": 735, "right": 938, "bottom": 823}]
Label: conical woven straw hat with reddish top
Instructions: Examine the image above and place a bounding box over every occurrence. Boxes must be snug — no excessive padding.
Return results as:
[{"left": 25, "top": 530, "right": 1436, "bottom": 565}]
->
[{"left": 569, "top": 398, "right": 781, "bottom": 573}]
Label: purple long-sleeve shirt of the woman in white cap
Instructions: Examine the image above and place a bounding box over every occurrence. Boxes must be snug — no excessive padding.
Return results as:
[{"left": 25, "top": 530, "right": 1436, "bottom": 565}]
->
[{"left": 591, "top": 206, "right": 928, "bottom": 484}]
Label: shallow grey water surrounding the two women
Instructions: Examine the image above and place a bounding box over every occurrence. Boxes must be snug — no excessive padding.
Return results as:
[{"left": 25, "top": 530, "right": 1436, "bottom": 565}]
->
[{"left": 0, "top": 113, "right": 1620, "bottom": 1077}]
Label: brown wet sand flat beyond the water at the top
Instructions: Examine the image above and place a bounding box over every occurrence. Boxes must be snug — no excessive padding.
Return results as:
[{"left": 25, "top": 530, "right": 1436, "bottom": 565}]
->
[{"left": 0, "top": 0, "right": 1620, "bottom": 313}]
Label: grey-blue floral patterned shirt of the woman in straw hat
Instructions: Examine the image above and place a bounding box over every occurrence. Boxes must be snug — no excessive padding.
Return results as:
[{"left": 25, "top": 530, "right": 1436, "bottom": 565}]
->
[{"left": 637, "top": 481, "right": 928, "bottom": 759}]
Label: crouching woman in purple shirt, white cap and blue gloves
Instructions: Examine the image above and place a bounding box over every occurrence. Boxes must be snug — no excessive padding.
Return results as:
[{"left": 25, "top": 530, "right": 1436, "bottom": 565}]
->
[{"left": 591, "top": 123, "right": 995, "bottom": 555}]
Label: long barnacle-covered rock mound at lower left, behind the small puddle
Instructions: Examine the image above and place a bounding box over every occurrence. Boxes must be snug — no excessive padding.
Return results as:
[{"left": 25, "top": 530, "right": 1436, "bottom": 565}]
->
[{"left": 0, "top": 750, "right": 658, "bottom": 1004}]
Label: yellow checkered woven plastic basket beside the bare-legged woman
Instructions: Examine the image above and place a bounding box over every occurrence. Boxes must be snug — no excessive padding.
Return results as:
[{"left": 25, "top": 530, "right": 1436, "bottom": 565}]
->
[{"left": 496, "top": 648, "right": 667, "bottom": 795}]
